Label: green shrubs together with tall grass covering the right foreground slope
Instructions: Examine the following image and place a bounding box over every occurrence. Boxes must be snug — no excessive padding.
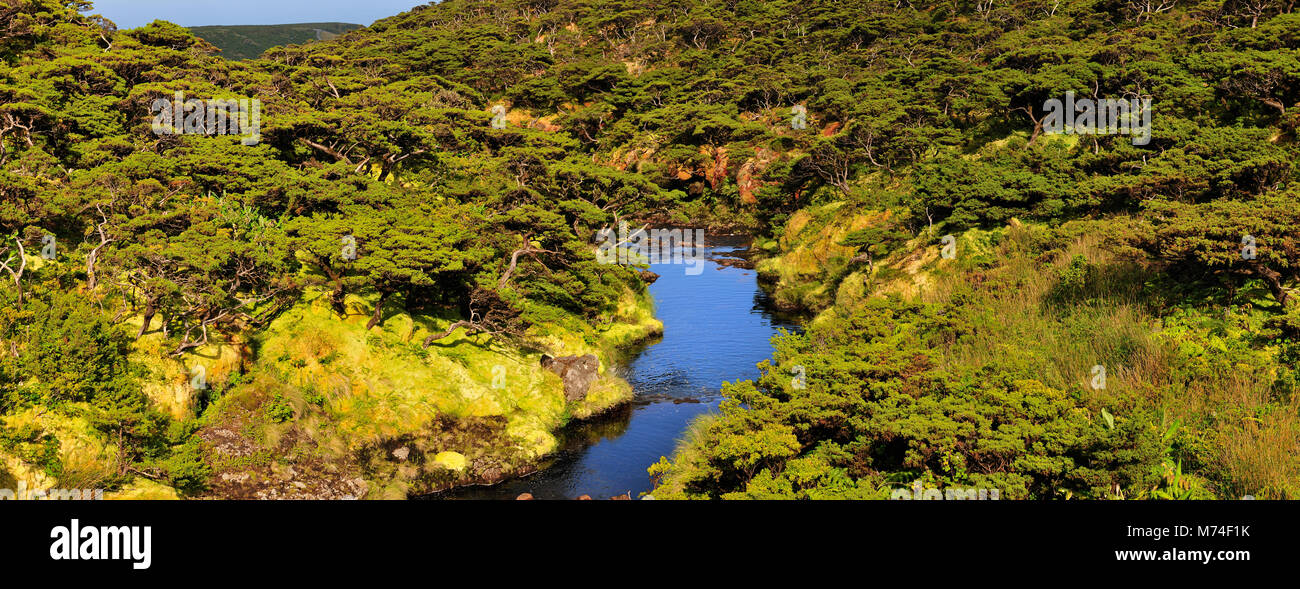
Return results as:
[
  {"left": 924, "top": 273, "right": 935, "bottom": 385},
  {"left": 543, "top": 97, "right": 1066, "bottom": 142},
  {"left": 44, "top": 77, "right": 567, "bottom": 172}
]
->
[{"left": 651, "top": 210, "right": 1300, "bottom": 498}]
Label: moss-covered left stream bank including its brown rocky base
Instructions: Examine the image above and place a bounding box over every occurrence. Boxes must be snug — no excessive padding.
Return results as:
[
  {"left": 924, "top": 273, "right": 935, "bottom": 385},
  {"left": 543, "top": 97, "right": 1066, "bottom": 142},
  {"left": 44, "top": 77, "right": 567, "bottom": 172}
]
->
[{"left": 188, "top": 282, "right": 662, "bottom": 498}]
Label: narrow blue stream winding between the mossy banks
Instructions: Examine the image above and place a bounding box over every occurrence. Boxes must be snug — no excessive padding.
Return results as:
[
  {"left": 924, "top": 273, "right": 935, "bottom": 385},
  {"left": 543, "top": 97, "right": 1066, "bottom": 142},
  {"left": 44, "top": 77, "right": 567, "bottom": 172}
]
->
[{"left": 446, "top": 236, "right": 796, "bottom": 499}]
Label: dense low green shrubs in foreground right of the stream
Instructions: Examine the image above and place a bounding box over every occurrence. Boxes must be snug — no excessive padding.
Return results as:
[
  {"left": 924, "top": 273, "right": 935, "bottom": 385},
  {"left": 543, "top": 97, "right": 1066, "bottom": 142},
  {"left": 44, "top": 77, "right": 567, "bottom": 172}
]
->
[{"left": 655, "top": 299, "right": 1161, "bottom": 498}]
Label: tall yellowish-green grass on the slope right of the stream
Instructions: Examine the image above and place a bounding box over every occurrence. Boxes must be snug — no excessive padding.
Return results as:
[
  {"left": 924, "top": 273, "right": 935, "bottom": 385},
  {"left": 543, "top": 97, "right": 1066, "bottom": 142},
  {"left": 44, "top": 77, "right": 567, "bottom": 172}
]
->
[{"left": 919, "top": 224, "right": 1300, "bottom": 498}]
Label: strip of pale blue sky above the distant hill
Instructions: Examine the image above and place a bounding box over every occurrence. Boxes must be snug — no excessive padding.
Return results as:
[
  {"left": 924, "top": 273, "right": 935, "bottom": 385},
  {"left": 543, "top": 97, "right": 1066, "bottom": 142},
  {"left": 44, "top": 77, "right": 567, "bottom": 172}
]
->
[{"left": 82, "top": 0, "right": 429, "bottom": 29}]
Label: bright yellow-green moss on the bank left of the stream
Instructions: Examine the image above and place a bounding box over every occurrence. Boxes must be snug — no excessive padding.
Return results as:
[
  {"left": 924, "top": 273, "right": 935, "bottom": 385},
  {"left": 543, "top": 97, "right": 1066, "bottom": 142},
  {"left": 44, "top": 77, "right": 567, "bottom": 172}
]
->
[{"left": 204, "top": 280, "right": 663, "bottom": 498}]
